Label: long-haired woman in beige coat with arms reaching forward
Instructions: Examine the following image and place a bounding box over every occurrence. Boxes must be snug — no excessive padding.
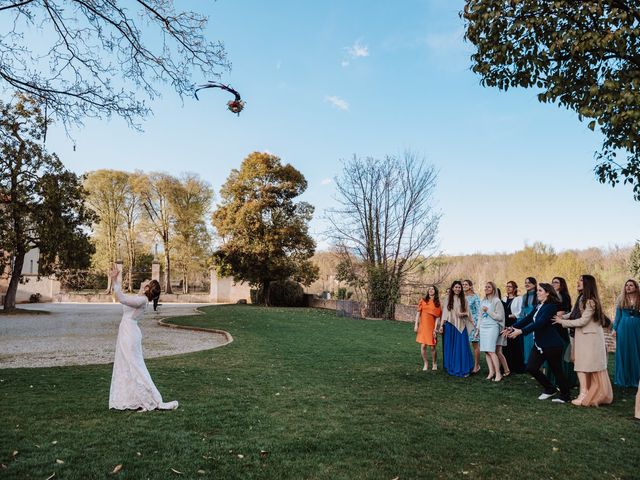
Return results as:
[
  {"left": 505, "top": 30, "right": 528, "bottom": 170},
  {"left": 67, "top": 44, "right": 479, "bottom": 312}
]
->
[{"left": 554, "top": 275, "right": 613, "bottom": 407}]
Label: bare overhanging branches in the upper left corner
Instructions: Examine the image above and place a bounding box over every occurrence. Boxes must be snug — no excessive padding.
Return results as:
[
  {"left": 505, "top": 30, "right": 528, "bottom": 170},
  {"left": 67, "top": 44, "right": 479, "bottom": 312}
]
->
[{"left": 0, "top": 0, "right": 229, "bottom": 125}]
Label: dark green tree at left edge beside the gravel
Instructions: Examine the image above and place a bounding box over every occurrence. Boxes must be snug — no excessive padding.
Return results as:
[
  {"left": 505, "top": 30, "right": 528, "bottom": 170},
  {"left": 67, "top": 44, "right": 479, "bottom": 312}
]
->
[{"left": 0, "top": 96, "right": 92, "bottom": 311}]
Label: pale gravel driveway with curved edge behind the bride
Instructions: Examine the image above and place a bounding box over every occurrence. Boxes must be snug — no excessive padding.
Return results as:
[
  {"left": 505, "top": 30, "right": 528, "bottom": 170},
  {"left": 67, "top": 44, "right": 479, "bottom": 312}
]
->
[{"left": 0, "top": 303, "right": 231, "bottom": 368}]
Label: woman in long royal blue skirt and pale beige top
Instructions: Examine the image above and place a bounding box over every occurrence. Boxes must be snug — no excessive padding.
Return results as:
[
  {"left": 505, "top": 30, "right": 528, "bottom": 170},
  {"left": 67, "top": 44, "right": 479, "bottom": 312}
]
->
[{"left": 440, "top": 280, "right": 474, "bottom": 377}]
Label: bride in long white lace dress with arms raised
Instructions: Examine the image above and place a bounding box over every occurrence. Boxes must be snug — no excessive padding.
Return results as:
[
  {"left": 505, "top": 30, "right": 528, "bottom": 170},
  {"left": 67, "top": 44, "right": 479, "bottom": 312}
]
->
[{"left": 109, "top": 266, "right": 178, "bottom": 411}]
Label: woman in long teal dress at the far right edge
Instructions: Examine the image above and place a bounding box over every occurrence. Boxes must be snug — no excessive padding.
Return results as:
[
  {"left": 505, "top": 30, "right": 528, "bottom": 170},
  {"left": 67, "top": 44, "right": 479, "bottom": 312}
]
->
[{"left": 612, "top": 279, "right": 640, "bottom": 388}]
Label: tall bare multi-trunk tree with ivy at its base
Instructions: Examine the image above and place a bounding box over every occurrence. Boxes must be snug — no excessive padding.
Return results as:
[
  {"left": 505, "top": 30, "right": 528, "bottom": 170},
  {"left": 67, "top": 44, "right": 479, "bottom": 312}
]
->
[{"left": 328, "top": 153, "right": 440, "bottom": 318}]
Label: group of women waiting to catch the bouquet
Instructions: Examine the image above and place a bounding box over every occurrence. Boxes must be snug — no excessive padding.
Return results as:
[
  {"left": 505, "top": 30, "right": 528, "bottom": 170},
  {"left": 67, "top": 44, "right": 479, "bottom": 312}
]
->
[{"left": 414, "top": 275, "right": 640, "bottom": 419}]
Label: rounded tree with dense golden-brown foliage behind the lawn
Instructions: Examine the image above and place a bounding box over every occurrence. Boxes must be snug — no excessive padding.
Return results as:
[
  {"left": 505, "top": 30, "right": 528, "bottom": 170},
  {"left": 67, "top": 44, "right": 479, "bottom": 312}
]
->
[{"left": 213, "top": 152, "right": 318, "bottom": 303}]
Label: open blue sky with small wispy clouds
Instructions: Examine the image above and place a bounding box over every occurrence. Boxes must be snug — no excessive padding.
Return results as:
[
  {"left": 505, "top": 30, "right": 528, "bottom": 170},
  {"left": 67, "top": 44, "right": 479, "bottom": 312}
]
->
[{"left": 17, "top": 0, "right": 640, "bottom": 254}]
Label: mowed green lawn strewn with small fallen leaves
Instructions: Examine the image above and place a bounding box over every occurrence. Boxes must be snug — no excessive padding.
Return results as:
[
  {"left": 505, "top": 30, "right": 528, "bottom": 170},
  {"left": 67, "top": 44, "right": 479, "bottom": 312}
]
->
[{"left": 0, "top": 306, "right": 640, "bottom": 480}]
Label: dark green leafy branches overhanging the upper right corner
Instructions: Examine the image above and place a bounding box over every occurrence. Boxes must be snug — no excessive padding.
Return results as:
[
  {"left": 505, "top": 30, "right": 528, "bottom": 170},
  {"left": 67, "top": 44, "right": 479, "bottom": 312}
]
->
[{"left": 462, "top": 0, "right": 640, "bottom": 200}]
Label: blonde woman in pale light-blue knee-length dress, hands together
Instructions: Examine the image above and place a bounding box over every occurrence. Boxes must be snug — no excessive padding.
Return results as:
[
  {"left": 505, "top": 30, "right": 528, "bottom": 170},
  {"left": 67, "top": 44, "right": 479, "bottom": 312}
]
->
[{"left": 477, "top": 282, "right": 506, "bottom": 382}]
